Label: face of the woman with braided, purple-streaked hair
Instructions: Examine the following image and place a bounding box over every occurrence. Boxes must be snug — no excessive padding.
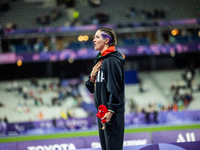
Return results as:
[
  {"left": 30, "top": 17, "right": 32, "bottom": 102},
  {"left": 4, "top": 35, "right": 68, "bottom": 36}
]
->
[{"left": 93, "top": 30, "right": 105, "bottom": 52}]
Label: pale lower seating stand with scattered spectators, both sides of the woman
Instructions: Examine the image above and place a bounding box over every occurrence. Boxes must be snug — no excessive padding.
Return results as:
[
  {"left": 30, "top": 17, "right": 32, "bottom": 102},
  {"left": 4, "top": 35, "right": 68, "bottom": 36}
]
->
[{"left": 0, "top": 67, "right": 200, "bottom": 122}]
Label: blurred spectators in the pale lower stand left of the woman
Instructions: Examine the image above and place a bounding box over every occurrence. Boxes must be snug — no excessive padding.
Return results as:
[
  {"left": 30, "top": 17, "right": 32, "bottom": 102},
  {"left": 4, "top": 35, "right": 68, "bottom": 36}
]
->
[{"left": 1, "top": 78, "right": 86, "bottom": 120}]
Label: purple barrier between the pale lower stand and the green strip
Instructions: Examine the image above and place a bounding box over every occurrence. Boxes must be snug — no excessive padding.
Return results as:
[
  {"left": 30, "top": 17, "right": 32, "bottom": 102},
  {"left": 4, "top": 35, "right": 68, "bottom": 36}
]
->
[{"left": 0, "top": 110, "right": 200, "bottom": 137}]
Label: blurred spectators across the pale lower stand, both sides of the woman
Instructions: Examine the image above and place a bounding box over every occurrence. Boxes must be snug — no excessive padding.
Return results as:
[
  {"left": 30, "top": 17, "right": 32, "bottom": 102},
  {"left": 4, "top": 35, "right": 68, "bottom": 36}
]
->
[{"left": 0, "top": 65, "right": 200, "bottom": 123}]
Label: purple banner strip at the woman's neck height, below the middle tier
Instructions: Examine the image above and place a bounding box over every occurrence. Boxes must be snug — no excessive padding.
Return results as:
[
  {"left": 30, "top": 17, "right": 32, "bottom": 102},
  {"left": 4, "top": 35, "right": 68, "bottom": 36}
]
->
[{"left": 0, "top": 42, "right": 200, "bottom": 64}]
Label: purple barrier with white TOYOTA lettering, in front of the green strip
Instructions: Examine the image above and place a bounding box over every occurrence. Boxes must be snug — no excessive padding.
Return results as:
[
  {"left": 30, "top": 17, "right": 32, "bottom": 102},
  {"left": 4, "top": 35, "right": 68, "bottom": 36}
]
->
[{"left": 0, "top": 129, "right": 200, "bottom": 150}]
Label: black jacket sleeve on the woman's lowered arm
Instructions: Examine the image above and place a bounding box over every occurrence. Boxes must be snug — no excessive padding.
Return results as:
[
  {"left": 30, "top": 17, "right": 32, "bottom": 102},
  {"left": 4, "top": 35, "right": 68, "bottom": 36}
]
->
[{"left": 103, "top": 57, "right": 124, "bottom": 111}]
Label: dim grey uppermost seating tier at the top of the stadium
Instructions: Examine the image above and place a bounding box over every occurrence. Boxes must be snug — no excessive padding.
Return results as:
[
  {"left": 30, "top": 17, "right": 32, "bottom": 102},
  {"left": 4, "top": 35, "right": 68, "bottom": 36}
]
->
[{"left": 1, "top": 0, "right": 198, "bottom": 28}]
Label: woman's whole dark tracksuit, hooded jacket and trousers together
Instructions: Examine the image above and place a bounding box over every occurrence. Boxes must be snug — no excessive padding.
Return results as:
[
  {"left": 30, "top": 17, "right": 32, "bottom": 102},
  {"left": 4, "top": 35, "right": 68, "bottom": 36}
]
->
[{"left": 85, "top": 50, "right": 125, "bottom": 150}]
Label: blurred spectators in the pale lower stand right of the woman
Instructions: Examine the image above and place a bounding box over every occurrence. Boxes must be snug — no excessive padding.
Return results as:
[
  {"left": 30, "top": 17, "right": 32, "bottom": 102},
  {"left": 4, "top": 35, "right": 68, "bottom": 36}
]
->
[{"left": 127, "top": 65, "right": 200, "bottom": 123}]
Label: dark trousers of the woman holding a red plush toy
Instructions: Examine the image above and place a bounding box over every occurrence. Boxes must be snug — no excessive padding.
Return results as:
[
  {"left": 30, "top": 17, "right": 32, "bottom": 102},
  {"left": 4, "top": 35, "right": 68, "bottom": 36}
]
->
[{"left": 98, "top": 112, "right": 124, "bottom": 150}]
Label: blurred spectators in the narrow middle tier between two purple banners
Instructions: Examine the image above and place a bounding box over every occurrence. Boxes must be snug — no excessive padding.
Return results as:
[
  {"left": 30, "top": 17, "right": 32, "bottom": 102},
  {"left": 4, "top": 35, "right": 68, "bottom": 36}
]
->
[{"left": 0, "top": 26, "right": 200, "bottom": 53}]
